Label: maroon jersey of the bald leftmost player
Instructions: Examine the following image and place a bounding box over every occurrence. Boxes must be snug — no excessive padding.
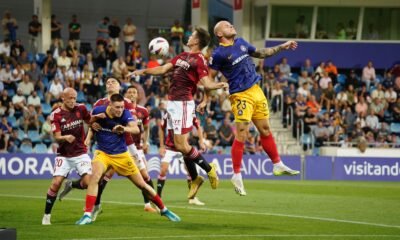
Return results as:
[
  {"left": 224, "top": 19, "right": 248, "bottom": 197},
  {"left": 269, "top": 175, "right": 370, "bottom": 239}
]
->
[{"left": 50, "top": 104, "right": 90, "bottom": 157}]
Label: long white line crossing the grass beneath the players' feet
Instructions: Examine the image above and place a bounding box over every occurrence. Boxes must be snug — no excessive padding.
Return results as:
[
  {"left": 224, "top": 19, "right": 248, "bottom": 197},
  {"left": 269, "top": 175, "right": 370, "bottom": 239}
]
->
[{"left": 0, "top": 194, "right": 400, "bottom": 229}]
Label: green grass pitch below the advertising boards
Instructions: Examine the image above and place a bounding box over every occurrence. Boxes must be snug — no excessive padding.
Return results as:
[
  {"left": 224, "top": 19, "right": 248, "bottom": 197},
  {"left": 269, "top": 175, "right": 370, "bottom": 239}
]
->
[{"left": 0, "top": 179, "right": 400, "bottom": 240}]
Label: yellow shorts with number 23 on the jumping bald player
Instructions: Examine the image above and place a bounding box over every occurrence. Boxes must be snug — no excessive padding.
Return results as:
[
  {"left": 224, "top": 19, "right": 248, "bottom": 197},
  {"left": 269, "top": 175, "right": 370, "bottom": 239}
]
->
[{"left": 229, "top": 84, "right": 269, "bottom": 122}]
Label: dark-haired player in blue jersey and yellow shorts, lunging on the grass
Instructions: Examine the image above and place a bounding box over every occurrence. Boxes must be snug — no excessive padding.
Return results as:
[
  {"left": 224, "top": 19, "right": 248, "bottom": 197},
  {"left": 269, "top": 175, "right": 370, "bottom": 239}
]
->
[{"left": 76, "top": 94, "right": 180, "bottom": 225}]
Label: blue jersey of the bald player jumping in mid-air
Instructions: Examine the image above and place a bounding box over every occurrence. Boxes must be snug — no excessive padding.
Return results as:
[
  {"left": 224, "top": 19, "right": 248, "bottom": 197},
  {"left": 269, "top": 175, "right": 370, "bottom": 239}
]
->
[{"left": 209, "top": 38, "right": 261, "bottom": 94}]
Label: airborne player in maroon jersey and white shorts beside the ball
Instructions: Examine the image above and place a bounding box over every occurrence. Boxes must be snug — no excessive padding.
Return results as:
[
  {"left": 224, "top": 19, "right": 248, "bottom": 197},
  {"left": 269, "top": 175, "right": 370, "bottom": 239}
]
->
[{"left": 132, "top": 28, "right": 227, "bottom": 199}]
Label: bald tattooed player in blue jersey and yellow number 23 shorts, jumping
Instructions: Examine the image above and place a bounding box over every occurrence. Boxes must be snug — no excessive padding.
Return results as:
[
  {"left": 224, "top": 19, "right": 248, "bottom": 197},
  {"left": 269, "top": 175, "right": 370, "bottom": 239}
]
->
[{"left": 209, "top": 21, "right": 299, "bottom": 196}]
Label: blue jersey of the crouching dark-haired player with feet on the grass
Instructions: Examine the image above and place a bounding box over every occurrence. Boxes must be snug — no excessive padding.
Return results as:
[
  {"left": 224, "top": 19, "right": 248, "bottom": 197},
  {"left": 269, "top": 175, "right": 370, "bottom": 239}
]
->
[{"left": 92, "top": 106, "right": 134, "bottom": 154}]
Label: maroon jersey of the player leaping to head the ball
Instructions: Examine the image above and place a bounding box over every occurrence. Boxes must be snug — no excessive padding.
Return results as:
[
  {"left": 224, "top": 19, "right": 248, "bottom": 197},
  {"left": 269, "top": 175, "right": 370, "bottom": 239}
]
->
[{"left": 168, "top": 52, "right": 208, "bottom": 101}]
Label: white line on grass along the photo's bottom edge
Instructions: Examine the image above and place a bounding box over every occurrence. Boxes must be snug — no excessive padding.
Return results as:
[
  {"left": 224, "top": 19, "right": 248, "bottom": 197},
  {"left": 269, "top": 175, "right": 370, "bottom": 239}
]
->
[{"left": 66, "top": 234, "right": 400, "bottom": 240}]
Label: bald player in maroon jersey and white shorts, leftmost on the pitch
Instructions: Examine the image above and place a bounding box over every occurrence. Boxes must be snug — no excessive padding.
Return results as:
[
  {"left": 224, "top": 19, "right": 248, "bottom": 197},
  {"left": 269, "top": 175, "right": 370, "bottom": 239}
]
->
[{"left": 42, "top": 88, "right": 92, "bottom": 225}]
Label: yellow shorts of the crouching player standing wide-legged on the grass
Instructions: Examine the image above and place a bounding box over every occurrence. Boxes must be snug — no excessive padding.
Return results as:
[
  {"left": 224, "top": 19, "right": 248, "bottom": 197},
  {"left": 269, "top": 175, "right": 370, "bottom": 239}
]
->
[{"left": 93, "top": 150, "right": 139, "bottom": 176}]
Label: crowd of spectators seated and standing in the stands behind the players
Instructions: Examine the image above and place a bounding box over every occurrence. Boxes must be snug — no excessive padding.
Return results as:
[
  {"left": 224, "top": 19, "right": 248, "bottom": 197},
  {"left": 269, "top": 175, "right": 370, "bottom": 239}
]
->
[{"left": 0, "top": 12, "right": 400, "bottom": 154}]
